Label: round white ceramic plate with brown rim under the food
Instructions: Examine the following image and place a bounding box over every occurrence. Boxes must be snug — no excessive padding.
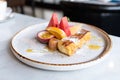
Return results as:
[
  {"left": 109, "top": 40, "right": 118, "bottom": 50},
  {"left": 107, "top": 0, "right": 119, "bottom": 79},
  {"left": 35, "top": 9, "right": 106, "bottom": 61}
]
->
[{"left": 10, "top": 22, "right": 111, "bottom": 71}]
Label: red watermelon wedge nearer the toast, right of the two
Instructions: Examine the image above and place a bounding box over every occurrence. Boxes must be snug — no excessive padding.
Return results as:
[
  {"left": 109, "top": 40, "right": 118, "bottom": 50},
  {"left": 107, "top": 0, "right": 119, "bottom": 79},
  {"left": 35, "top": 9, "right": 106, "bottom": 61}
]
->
[{"left": 59, "top": 17, "right": 71, "bottom": 36}]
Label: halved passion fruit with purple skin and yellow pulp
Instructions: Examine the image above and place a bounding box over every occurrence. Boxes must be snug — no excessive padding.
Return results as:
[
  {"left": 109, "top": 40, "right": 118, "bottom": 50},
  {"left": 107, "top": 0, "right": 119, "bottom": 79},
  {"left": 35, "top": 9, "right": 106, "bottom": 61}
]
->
[{"left": 37, "top": 30, "right": 54, "bottom": 43}]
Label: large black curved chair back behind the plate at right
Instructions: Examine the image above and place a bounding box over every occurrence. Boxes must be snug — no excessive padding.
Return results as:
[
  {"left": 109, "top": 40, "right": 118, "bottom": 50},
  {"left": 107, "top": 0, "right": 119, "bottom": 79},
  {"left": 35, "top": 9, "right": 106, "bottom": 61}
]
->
[{"left": 61, "top": 1, "right": 120, "bottom": 36}]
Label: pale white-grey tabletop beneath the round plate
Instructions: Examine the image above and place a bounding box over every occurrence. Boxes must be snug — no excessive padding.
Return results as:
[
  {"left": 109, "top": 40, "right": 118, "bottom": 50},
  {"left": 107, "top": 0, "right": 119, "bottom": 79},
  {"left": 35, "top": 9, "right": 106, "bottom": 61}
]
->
[{"left": 0, "top": 13, "right": 120, "bottom": 80}]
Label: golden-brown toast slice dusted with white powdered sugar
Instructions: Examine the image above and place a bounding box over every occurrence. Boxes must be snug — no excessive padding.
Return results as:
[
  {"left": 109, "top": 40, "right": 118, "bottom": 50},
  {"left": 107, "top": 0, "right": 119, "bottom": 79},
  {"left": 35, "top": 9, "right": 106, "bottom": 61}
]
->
[{"left": 58, "top": 29, "right": 91, "bottom": 56}]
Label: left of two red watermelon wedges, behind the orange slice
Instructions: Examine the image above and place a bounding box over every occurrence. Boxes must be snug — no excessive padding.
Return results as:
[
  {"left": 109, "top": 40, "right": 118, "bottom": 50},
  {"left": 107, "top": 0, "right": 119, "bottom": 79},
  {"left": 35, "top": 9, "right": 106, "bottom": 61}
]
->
[{"left": 48, "top": 13, "right": 59, "bottom": 27}]
